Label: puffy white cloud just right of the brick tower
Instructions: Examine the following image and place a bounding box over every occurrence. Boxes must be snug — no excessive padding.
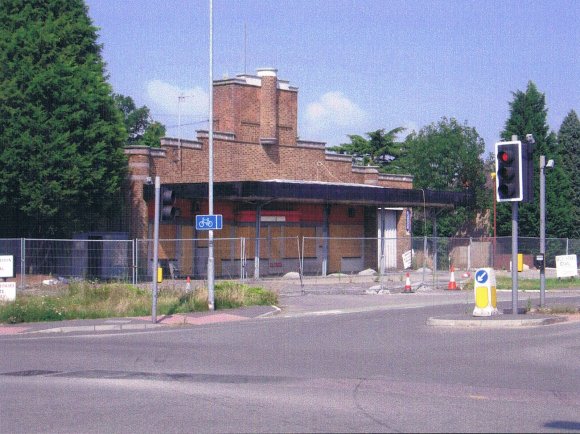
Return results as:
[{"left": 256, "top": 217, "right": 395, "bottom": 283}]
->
[{"left": 300, "top": 92, "right": 368, "bottom": 144}]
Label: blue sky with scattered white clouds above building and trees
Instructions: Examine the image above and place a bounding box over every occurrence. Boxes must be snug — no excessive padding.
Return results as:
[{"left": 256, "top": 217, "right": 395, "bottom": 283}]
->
[{"left": 85, "top": 0, "right": 580, "bottom": 156}]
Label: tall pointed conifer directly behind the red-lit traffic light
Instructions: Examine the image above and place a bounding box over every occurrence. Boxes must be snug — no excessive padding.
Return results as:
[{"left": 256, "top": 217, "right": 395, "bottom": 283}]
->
[{"left": 497, "top": 81, "right": 574, "bottom": 237}]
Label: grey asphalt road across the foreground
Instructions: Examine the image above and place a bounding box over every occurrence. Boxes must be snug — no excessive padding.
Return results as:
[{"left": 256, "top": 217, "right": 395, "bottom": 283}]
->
[{"left": 0, "top": 296, "right": 580, "bottom": 433}]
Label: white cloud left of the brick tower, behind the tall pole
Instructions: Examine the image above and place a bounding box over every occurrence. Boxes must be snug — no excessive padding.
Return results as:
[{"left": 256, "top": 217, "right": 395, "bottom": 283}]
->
[{"left": 147, "top": 80, "right": 209, "bottom": 120}]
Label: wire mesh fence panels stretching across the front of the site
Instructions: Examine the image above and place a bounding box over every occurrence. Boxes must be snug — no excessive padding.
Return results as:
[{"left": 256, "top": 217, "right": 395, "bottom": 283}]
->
[{"left": 0, "top": 237, "right": 580, "bottom": 289}]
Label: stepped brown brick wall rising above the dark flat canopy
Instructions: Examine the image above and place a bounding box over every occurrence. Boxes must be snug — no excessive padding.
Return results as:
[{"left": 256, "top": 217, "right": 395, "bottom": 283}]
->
[{"left": 125, "top": 69, "right": 413, "bottom": 244}]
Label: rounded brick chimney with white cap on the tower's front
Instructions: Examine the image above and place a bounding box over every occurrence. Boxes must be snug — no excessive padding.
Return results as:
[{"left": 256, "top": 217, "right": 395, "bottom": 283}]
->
[{"left": 257, "top": 68, "right": 278, "bottom": 145}]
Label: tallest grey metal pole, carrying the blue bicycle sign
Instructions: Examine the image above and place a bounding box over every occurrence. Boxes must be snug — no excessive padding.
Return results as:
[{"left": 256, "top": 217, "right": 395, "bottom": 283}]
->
[{"left": 207, "top": 0, "right": 215, "bottom": 311}]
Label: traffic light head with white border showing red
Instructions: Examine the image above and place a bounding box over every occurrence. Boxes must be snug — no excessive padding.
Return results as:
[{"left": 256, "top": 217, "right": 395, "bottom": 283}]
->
[{"left": 495, "top": 140, "right": 524, "bottom": 202}]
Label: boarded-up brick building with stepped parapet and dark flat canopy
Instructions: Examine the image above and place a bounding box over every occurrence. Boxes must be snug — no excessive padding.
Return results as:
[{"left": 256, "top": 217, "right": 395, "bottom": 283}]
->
[{"left": 126, "top": 69, "right": 465, "bottom": 277}]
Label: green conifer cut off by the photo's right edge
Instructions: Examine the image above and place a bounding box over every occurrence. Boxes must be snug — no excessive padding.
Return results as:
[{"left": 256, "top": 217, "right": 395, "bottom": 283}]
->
[{"left": 550, "top": 110, "right": 580, "bottom": 238}]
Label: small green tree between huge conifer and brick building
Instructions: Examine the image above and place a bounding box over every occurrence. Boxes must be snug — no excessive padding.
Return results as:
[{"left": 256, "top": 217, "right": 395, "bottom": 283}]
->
[{"left": 113, "top": 94, "right": 165, "bottom": 147}]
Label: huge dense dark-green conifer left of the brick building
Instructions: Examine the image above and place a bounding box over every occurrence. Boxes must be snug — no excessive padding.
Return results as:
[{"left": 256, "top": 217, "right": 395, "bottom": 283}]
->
[{"left": 0, "top": 0, "right": 126, "bottom": 237}]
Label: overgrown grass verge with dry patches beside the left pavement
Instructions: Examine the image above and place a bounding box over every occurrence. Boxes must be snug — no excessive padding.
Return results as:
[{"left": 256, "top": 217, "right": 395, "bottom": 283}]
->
[{"left": 0, "top": 282, "right": 278, "bottom": 324}]
